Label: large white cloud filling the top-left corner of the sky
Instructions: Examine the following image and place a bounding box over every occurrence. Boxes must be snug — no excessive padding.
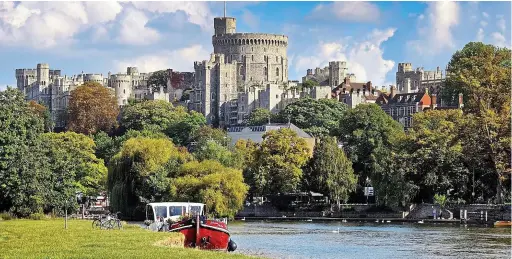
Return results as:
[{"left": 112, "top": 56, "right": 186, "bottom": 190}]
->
[{"left": 0, "top": 2, "right": 122, "bottom": 49}]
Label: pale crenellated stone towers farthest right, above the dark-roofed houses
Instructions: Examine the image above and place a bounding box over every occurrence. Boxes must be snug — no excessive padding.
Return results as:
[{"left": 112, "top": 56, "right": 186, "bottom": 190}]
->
[{"left": 396, "top": 63, "right": 445, "bottom": 93}]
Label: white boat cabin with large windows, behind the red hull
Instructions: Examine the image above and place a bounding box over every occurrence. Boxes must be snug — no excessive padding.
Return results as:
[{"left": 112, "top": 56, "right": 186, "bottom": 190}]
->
[{"left": 146, "top": 202, "right": 204, "bottom": 222}]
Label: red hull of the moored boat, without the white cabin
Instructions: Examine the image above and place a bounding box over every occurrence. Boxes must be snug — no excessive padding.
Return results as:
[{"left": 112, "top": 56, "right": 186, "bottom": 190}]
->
[{"left": 169, "top": 219, "right": 230, "bottom": 251}]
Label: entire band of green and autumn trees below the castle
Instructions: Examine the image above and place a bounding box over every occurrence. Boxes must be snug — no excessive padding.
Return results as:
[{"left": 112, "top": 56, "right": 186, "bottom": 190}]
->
[{"left": 0, "top": 43, "right": 510, "bottom": 217}]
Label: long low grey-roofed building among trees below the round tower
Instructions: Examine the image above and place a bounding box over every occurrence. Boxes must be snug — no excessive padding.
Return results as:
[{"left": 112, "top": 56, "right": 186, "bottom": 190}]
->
[{"left": 227, "top": 123, "right": 315, "bottom": 152}]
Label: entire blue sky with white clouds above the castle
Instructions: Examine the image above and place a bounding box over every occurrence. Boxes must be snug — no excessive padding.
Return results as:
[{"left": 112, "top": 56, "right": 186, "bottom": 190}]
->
[{"left": 0, "top": 1, "right": 511, "bottom": 89}]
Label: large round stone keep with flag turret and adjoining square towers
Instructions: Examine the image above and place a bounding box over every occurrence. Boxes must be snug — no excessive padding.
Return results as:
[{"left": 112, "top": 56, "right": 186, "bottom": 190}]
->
[{"left": 189, "top": 14, "right": 300, "bottom": 127}]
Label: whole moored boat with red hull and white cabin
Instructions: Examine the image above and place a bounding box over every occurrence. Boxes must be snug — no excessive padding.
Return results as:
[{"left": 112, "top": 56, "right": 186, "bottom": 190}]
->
[{"left": 146, "top": 202, "right": 236, "bottom": 252}]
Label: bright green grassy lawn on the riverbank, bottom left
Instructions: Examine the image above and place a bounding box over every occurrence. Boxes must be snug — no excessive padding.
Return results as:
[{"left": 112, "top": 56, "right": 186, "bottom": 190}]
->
[{"left": 0, "top": 219, "right": 253, "bottom": 259}]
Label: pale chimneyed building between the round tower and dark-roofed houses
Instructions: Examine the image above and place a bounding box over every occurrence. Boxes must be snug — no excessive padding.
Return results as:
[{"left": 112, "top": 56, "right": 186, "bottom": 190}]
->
[{"left": 331, "top": 77, "right": 380, "bottom": 109}]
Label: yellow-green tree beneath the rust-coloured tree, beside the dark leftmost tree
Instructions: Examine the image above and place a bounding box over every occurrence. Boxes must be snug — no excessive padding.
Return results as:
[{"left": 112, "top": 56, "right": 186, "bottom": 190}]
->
[{"left": 42, "top": 132, "right": 107, "bottom": 211}]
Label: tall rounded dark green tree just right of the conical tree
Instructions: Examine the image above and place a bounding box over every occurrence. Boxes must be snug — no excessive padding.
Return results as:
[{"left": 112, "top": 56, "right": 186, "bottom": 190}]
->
[{"left": 339, "top": 104, "right": 404, "bottom": 203}]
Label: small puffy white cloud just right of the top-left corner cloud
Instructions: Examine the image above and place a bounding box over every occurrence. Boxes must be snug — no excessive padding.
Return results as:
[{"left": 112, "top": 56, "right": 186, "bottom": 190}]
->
[{"left": 117, "top": 8, "right": 160, "bottom": 45}]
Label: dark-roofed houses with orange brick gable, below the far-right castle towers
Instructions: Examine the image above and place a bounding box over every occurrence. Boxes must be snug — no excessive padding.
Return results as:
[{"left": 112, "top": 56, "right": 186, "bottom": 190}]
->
[{"left": 375, "top": 86, "right": 464, "bottom": 129}]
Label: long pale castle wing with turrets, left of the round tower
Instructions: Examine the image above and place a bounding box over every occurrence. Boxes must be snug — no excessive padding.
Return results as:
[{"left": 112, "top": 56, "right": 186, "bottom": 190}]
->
[{"left": 16, "top": 63, "right": 193, "bottom": 127}]
